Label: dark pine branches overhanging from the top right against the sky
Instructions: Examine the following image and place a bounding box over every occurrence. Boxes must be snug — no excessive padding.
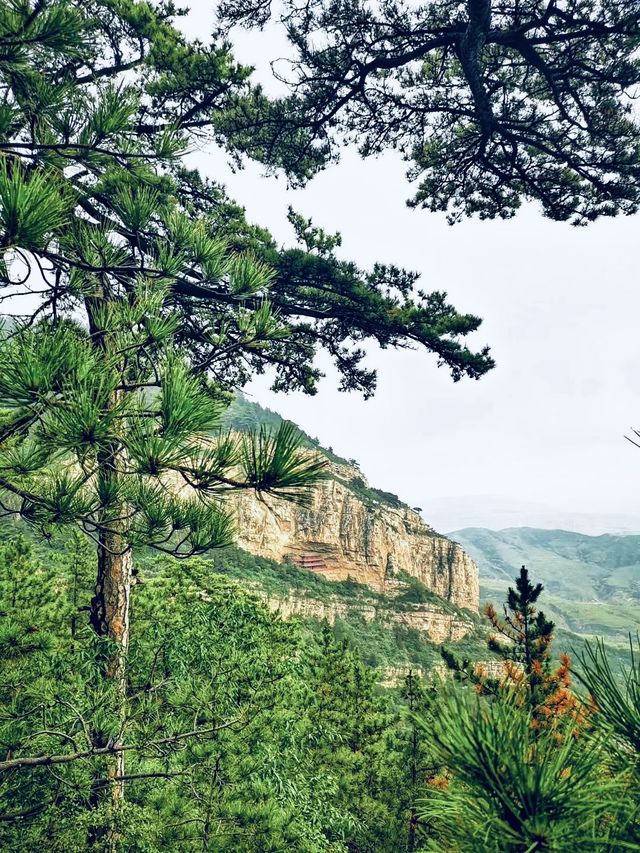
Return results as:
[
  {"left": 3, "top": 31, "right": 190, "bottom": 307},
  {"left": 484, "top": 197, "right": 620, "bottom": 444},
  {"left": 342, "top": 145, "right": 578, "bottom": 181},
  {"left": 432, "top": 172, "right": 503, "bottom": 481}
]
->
[{"left": 220, "top": 0, "right": 640, "bottom": 223}]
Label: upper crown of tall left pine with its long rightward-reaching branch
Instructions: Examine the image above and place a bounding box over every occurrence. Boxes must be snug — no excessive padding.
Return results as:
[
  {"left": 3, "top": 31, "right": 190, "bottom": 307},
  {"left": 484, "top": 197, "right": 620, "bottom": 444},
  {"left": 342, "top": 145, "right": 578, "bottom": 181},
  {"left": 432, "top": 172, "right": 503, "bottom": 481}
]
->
[{"left": 0, "top": 0, "right": 493, "bottom": 412}]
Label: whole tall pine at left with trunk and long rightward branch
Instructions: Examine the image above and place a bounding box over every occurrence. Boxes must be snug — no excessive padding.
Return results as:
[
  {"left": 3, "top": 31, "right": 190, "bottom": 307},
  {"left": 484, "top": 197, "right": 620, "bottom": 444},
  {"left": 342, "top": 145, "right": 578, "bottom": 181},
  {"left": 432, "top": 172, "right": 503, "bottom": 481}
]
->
[{"left": 0, "top": 0, "right": 502, "bottom": 832}]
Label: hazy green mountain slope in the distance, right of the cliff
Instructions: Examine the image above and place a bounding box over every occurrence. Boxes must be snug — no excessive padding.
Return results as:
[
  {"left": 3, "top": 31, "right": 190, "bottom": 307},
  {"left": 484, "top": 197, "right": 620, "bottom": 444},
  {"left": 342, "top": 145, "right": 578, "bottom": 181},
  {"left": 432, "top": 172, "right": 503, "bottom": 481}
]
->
[{"left": 448, "top": 527, "right": 640, "bottom": 645}]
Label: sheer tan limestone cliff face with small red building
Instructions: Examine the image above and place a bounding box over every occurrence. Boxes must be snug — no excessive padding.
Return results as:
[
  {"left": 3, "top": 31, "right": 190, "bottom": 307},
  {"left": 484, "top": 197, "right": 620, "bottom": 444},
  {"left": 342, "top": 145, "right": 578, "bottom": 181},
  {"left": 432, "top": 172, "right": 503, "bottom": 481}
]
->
[{"left": 234, "top": 465, "right": 479, "bottom": 611}]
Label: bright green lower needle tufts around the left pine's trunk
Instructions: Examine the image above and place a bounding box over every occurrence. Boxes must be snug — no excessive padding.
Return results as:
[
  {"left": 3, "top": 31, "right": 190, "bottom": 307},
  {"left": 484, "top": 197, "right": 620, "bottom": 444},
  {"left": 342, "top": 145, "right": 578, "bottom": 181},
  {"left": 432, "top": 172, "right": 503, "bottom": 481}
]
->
[{"left": 0, "top": 310, "right": 322, "bottom": 554}]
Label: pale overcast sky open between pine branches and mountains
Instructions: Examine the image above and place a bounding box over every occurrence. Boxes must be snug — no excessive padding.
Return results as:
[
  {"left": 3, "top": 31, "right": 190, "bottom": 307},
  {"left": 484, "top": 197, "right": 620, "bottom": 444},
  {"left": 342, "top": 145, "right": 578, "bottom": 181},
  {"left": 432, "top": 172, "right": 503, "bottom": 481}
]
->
[{"left": 180, "top": 3, "right": 640, "bottom": 532}]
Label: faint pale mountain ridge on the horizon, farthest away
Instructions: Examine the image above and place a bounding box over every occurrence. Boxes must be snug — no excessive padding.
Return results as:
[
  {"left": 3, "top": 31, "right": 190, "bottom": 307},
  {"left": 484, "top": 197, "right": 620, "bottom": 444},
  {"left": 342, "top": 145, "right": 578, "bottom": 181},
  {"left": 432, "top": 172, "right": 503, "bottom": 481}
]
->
[{"left": 423, "top": 495, "right": 640, "bottom": 536}]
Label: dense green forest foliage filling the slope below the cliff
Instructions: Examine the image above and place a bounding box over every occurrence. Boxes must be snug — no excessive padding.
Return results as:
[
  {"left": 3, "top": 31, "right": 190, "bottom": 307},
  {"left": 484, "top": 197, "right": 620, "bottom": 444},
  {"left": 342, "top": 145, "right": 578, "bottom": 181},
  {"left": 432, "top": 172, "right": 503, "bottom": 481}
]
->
[{"left": 0, "top": 526, "right": 640, "bottom": 853}]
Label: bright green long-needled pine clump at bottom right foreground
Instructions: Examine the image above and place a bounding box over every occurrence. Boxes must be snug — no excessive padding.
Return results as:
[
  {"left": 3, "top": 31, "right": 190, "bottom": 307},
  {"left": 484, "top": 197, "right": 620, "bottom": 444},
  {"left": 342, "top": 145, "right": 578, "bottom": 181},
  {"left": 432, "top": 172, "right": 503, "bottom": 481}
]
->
[{"left": 420, "top": 692, "right": 637, "bottom": 853}]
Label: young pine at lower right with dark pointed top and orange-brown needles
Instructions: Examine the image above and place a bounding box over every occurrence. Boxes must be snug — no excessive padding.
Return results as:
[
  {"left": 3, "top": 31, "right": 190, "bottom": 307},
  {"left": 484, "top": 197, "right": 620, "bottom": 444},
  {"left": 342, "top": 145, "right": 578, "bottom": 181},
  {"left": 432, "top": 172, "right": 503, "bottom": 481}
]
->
[{"left": 418, "top": 566, "right": 640, "bottom": 853}]
